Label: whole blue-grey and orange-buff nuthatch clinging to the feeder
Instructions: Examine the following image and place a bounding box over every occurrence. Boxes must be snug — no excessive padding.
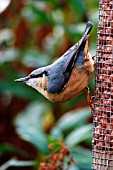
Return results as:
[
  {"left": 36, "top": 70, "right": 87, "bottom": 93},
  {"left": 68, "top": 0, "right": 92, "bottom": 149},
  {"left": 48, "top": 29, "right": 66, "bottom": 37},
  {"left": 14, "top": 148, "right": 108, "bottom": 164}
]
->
[{"left": 16, "top": 21, "right": 94, "bottom": 106}]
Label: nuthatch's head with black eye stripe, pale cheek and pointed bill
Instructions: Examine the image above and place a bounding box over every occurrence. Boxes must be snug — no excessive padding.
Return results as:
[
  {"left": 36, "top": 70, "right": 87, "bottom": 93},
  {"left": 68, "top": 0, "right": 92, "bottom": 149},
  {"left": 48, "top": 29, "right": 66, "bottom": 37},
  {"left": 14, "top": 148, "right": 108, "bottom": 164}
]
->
[{"left": 15, "top": 68, "right": 47, "bottom": 92}]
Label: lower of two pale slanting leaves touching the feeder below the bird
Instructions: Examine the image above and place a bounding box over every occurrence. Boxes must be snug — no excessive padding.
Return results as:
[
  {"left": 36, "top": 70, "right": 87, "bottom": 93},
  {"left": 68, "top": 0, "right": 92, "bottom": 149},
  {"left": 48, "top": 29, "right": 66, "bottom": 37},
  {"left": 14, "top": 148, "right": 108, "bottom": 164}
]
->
[{"left": 65, "top": 124, "right": 93, "bottom": 147}]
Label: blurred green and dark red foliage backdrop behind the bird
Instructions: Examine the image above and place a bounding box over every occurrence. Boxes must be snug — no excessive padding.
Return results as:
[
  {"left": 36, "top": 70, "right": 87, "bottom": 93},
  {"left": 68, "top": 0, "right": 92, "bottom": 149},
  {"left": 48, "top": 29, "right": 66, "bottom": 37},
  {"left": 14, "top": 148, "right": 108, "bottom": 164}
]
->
[{"left": 0, "top": 0, "right": 99, "bottom": 170}]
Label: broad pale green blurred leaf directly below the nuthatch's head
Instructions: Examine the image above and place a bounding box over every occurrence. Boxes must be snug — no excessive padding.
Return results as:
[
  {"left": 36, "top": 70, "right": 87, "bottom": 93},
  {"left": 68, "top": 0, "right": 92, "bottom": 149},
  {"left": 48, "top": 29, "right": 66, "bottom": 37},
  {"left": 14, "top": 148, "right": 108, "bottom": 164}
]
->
[{"left": 15, "top": 101, "right": 49, "bottom": 153}]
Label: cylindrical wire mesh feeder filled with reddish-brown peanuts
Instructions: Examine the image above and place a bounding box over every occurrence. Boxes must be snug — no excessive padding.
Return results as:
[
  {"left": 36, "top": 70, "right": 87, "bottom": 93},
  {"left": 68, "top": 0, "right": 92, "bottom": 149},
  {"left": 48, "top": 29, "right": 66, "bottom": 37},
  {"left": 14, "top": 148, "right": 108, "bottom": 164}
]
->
[{"left": 92, "top": 0, "right": 113, "bottom": 170}]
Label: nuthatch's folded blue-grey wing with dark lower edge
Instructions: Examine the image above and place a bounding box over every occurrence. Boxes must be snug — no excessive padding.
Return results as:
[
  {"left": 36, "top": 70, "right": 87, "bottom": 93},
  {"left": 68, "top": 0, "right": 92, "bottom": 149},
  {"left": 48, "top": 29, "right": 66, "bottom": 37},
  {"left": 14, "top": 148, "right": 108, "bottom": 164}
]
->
[{"left": 47, "top": 46, "right": 77, "bottom": 94}]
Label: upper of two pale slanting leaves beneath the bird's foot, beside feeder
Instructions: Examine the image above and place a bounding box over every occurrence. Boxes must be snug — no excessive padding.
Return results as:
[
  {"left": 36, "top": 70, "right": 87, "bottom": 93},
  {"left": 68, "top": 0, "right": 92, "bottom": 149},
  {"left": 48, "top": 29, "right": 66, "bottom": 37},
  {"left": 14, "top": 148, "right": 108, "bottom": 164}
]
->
[{"left": 51, "top": 107, "right": 91, "bottom": 139}]
